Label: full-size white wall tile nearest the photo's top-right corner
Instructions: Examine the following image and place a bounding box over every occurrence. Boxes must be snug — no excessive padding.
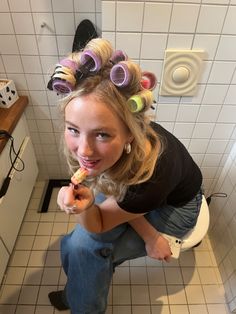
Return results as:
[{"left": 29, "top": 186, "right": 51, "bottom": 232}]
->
[{"left": 197, "top": 5, "right": 227, "bottom": 34}]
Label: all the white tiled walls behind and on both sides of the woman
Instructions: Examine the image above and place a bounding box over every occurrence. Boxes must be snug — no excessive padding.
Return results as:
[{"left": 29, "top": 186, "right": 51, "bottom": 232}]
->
[{"left": 0, "top": 0, "right": 236, "bottom": 305}]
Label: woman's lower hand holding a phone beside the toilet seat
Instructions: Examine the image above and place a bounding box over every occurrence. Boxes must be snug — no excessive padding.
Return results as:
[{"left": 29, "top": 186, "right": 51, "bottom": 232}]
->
[{"left": 145, "top": 233, "right": 171, "bottom": 262}]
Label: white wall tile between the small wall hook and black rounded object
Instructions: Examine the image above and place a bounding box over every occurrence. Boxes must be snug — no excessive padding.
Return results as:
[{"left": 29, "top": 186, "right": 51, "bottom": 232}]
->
[{"left": 54, "top": 13, "right": 75, "bottom": 35}]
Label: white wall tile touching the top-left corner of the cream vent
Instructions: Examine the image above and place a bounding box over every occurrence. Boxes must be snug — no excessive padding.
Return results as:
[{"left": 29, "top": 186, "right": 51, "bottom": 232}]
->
[{"left": 141, "top": 33, "right": 167, "bottom": 59}]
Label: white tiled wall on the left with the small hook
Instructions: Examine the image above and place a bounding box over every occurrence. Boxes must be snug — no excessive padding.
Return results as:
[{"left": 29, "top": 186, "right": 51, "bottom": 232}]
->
[{"left": 0, "top": 0, "right": 101, "bottom": 179}]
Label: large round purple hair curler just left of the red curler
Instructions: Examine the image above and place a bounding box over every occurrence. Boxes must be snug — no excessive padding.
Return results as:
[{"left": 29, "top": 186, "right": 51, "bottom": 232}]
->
[{"left": 110, "top": 62, "right": 131, "bottom": 87}]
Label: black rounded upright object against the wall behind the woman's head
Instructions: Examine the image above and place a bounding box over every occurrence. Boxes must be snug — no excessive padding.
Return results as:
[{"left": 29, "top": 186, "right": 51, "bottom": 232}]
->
[{"left": 72, "top": 20, "right": 98, "bottom": 52}]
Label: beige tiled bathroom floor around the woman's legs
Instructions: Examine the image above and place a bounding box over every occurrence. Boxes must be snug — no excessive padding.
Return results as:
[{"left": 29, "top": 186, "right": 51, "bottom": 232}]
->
[{"left": 0, "top": 182, "right": 229, "bottom": 314}]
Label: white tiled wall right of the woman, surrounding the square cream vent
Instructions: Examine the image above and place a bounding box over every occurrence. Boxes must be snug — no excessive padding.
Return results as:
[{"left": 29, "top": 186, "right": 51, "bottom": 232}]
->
[{"left": 102, "top": 0, "right": 236, "bottom": 310}]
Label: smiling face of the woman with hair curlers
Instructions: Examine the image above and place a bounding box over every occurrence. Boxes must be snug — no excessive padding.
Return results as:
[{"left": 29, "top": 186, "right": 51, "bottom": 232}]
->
[{"left": 65, "top": 94, "right": 132, "bottom": 176}]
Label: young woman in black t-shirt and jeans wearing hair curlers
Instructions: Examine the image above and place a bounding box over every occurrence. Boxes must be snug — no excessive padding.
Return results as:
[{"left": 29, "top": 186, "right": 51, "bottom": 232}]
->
[{"left": 49, "top": 38, "right": 202, "bottom": 314}]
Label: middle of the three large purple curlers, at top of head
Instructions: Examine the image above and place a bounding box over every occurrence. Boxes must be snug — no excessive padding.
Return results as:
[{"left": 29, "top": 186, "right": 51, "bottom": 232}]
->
[{"left": 80, "top": 50, "right": 102, "bottom": 72}]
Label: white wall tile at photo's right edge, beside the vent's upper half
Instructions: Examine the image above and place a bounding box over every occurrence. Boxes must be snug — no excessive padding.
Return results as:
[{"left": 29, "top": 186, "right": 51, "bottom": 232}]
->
[{"left": 208, "top": 61, "right": 236, "bottom": 84}]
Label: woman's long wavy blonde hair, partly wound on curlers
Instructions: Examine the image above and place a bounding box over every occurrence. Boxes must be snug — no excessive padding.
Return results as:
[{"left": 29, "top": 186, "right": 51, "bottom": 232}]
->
[{"left": 60, "top": 38, "right": 162, "bottom": 200}]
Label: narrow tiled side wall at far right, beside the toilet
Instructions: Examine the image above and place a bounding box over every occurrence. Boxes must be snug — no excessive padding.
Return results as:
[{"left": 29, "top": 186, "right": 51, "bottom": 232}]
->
[{"left": 209, "top": 144, "right": 236, "bottom": 310}]
